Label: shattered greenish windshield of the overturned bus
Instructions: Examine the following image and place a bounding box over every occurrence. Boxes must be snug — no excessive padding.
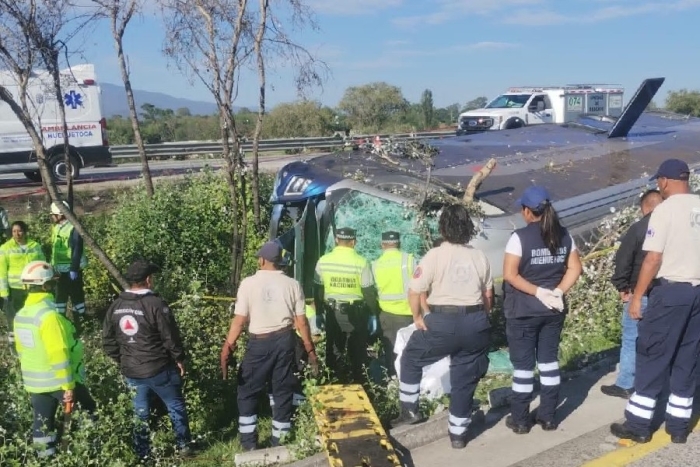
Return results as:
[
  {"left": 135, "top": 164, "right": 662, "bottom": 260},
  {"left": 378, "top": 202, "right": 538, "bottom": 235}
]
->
[{"left": 326, "top": 190, "right": 438, "bottom": 261}]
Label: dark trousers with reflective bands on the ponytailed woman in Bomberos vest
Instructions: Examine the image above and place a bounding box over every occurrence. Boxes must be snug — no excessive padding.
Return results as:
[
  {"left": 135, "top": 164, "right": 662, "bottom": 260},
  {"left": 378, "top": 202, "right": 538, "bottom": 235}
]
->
[{"left": 506, "top": 314, "right": 565, "bottom": 425}]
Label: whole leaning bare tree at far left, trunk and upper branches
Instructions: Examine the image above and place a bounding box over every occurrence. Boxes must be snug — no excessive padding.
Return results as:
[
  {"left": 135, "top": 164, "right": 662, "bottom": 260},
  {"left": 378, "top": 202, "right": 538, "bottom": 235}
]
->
[{"left": 0, "top": 0, "right": 128, "bottom": 288}]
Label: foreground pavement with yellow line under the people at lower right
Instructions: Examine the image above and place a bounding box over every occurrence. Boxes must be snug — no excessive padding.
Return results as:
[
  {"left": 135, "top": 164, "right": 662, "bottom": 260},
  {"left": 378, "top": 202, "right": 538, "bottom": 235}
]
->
[{"left": 406, "top": 370, "right": 700, "bottom": 467}]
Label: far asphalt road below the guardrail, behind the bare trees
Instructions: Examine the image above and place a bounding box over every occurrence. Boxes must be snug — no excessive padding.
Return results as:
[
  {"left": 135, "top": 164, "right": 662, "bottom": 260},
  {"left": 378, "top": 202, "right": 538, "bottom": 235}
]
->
[{"left": 0, "top": 154, "right": 306, "bottom": 198}]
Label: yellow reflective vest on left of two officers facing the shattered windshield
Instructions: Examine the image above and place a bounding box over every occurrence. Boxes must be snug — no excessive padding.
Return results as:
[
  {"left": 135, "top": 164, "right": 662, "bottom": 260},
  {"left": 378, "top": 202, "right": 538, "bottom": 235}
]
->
[{"left": 316, "top": 246, "right": 371, "bottom": 302}]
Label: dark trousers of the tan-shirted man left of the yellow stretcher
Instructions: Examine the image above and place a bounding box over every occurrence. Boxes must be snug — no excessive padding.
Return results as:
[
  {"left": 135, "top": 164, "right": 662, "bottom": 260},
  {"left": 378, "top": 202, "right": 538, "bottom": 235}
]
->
[{"left": 238, "top": 330, "right": 298, "bottom": 449}]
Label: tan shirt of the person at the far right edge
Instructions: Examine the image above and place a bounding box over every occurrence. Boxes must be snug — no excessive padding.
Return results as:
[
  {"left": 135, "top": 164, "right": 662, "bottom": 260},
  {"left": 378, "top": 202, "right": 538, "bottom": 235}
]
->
[{"left": 642, "top": 194, "right": 700, "bottom": 285}]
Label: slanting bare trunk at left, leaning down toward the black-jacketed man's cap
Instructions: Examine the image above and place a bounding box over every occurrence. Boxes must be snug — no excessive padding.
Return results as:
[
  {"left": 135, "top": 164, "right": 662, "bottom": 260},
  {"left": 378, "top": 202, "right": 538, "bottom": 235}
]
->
[{"left": 0, "top": 86, "right": 129, "bottom": 289}]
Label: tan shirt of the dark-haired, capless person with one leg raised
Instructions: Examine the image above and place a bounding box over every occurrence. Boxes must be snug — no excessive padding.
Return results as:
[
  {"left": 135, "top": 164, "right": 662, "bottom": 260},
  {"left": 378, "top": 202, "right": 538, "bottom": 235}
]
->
[{"left": 409, "top": 242, "right": 493, "bottom": 306}]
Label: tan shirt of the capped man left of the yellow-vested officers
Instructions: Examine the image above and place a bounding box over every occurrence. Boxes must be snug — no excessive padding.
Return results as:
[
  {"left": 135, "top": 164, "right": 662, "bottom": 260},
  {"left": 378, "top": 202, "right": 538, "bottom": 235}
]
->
[{"left": 234, "top": 271, "right": 305, "bottom": 334}]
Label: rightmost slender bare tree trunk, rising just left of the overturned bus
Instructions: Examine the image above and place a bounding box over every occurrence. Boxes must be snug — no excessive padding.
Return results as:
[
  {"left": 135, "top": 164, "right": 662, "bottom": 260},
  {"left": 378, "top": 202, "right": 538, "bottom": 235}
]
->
[{"left": 251, "top": 0, "right": 269, "bottom": 232}]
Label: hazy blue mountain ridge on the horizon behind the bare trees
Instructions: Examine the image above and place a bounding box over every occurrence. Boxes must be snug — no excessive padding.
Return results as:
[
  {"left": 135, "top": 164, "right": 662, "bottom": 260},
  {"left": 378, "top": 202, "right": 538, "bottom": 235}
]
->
[{"left": 100, "top": 83, "right": 247, "bottom": 117}]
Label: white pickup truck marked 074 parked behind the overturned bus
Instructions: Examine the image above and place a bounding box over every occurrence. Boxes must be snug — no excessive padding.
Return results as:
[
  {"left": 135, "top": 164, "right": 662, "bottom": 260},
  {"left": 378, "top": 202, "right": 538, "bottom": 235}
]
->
[{"left": 457, "top": 84, "right": 624, "bottom": 136}]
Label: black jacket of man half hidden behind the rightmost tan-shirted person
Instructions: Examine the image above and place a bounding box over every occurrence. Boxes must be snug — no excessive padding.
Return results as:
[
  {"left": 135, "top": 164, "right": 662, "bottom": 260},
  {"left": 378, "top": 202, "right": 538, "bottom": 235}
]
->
[{"left": 610, "top": 213, "right": 651, "bottom": 292}]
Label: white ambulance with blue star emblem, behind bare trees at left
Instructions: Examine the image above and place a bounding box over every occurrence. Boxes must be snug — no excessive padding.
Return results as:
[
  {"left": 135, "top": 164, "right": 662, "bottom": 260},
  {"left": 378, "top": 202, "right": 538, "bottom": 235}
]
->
[{"left": 0, "top": 64, "right": 112, "bottom": 181}]
